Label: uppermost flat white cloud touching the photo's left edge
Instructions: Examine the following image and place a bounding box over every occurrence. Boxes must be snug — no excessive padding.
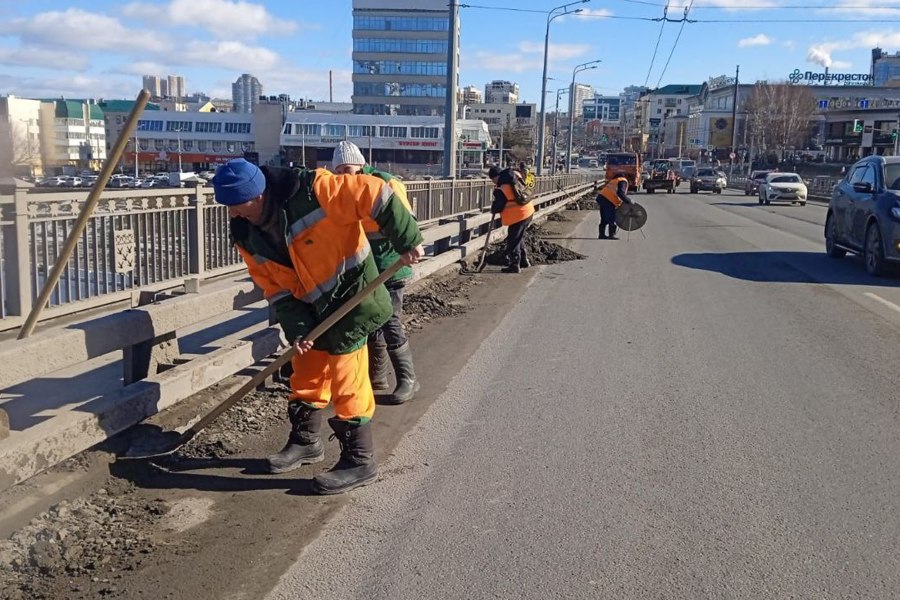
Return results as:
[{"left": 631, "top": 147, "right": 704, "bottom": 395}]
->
[{"left": 0, "top": 8, "right": 161, "bottom": 52}]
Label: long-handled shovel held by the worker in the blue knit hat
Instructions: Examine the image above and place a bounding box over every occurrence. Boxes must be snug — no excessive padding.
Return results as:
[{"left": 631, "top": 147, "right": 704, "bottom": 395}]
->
[{"left": 122, "top": 260, "right": 403, "bottom": 460}]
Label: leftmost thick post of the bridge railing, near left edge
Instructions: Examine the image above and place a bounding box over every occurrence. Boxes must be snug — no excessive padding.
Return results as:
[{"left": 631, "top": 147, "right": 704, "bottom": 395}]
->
[{"left": 3, "top": 189, "right": 32, "bottom": 317}]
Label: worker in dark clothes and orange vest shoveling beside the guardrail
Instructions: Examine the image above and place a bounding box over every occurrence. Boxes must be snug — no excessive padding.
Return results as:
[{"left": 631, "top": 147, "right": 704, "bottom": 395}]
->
[{"left": 488, "top": 167, "right": 534, "bottom": 273}]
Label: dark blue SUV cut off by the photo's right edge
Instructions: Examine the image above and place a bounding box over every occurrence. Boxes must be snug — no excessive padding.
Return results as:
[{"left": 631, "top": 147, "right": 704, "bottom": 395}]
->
[{"left": 825, "top": 156, "right": 900, "bottom": 275}]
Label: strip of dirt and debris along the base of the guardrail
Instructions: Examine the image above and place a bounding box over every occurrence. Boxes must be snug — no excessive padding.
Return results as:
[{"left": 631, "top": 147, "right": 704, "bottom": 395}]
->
[{"left": 0, "top": 207, "right": 582, "bottom": 600}]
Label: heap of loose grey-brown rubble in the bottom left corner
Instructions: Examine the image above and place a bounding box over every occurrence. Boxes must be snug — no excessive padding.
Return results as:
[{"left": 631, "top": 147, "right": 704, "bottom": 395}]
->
[{"left": 0, "top": 480, "right": 168, "bottom": 600}]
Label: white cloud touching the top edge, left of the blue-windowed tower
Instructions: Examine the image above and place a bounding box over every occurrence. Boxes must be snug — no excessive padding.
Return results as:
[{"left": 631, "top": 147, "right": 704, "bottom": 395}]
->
[{"left": 122, "top": 0, "right": 297, "bottom": 38}]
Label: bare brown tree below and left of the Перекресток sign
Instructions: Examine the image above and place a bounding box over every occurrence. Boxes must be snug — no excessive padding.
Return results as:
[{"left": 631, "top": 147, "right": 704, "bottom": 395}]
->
[{"left": 744, "top": 81, "right": 816, "bottom": 160}]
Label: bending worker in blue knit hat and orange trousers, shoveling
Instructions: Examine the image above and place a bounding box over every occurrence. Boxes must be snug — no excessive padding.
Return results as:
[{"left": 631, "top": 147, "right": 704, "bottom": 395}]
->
[{"left": 213, "top": 158, "right": 423, "bottom": 494}]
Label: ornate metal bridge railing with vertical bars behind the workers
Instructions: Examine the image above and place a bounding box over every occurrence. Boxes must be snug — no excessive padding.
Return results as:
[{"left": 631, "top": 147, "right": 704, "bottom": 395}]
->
[{"left": 0, "top": 175, "right": 588, "bottom": 319}]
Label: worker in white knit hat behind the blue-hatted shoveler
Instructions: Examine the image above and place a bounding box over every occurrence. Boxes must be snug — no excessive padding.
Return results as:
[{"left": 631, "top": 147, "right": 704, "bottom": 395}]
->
[{"left": 331, "top": 141, "right": 419, "bottom": 404}]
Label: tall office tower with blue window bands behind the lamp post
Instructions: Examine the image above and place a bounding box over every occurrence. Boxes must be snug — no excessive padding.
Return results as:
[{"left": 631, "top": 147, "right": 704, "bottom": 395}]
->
[{"left": 352, "top": 0, "right": 459, "bottom": 116}]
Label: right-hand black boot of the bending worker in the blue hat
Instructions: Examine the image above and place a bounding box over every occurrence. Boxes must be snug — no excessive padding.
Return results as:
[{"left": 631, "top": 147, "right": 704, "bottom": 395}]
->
[{"left": 313, "top": 418, "right": 378, "bottom": 496}]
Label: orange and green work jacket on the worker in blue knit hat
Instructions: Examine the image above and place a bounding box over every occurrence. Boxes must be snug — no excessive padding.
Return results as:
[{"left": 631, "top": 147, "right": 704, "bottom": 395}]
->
[{"left": 231, "top": 167, "right": 422, "bottom": 354}]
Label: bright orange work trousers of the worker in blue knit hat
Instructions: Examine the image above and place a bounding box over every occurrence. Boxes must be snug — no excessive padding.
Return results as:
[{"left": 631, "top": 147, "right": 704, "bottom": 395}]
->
[{"left": 291, "top": 344, "right": 375, "bottom": 425}]
